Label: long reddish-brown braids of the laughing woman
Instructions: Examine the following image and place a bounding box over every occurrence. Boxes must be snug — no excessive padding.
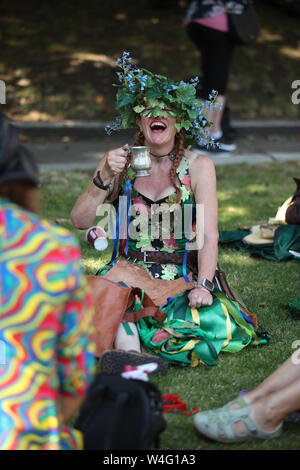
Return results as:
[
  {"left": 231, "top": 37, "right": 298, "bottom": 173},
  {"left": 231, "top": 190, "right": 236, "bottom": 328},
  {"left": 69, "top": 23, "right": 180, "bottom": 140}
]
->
[{"left": 109, "top": 129, "right": 184, "bottom": 203}]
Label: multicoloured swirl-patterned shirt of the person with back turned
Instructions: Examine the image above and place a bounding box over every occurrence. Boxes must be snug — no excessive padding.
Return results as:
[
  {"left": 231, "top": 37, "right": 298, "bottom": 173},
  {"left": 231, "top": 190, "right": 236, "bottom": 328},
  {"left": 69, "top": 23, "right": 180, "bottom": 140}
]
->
[{"left": 0, "top": 198, "right": 95, "bottom": 450}]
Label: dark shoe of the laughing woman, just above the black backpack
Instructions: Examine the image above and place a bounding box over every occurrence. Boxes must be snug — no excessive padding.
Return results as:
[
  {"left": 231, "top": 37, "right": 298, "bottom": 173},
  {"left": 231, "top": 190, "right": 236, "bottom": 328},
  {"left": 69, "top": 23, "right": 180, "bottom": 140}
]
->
[{"left": 100, "top": 349, "right": 168, "bottom": 375}]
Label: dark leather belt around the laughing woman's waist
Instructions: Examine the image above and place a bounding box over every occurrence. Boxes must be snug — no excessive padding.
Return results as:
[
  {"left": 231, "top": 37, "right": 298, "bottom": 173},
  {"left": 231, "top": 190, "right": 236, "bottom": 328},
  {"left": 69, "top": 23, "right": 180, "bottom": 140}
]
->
[{"left": 123, "top": 249, "right": 198, "bottom": 272}]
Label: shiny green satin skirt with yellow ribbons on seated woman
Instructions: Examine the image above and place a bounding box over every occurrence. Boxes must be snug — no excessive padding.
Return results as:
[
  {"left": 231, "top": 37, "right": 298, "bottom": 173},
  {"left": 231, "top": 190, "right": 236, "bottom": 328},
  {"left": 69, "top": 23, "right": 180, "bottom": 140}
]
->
[{"left": 136, "top": 290, "right": 270, "bottom": 367}]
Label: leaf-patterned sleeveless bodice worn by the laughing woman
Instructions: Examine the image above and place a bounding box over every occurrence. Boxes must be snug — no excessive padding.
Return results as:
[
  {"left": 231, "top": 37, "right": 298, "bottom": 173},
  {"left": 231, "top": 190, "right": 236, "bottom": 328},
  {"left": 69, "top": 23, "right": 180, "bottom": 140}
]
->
[{"left": 118, "top": 157, "right": 196, "bottom": 280}]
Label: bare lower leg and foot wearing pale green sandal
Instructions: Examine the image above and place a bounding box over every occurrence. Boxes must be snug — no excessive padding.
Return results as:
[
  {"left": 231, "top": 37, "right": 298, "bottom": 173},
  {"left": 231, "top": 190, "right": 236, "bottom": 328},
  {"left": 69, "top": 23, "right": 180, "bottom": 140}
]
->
[{"left": 195, "top": 350, "right": 300, "bottom": 442}]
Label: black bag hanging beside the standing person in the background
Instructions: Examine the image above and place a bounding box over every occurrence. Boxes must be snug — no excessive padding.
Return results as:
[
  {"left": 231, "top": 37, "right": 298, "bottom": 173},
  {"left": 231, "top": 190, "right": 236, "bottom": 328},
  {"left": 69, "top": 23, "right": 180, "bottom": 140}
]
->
[{"left": 228, "top": 0, "right": 259, "bottom": 44}]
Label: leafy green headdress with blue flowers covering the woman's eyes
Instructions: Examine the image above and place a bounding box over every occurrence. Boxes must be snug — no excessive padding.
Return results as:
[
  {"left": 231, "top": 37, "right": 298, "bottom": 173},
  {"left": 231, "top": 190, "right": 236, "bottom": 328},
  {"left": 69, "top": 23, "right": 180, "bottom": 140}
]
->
[{"left": 106, "top": 52, "right": 217, "bottom": 146}]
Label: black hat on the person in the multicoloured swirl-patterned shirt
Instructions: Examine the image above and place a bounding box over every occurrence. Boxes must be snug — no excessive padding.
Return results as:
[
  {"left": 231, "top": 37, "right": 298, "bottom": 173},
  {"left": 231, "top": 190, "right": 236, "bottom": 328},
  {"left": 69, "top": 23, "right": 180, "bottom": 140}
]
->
[{"left": 0, "top": 115, "right": 39, "bottom": 187}]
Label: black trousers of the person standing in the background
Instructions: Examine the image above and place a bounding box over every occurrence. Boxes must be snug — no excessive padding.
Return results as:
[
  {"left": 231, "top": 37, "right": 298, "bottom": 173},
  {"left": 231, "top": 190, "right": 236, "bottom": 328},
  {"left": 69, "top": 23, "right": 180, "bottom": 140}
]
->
[{"left": 185, "top": 22, "right": 234, "bottom": 99}]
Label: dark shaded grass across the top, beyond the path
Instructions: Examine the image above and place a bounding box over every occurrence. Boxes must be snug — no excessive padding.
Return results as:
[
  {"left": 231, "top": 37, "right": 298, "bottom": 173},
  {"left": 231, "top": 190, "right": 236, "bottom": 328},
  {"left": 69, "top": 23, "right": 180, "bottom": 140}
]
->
[{"left": 0, "top": 0, "right": 300, "bottom": 121}]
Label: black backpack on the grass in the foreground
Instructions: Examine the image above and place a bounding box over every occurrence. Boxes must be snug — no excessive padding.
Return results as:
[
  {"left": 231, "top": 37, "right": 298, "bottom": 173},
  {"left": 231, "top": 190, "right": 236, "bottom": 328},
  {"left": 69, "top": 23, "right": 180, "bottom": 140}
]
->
[{"left": 74, "top": 374, "right": 166, "bottom": 450}]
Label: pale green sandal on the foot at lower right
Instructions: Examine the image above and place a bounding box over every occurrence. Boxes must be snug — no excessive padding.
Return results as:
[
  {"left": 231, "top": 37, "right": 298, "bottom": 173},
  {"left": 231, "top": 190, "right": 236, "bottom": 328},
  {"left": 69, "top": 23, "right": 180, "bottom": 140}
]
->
[{"left": 194, "top": 397, "right": 282, "bottom": 443}]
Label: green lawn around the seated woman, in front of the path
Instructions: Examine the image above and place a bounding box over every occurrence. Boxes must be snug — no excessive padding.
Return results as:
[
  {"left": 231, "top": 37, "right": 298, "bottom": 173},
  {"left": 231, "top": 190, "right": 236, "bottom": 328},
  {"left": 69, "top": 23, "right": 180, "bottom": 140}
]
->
[{"left": 40, "top": 162, "right": 300, "bottom": 450}]
